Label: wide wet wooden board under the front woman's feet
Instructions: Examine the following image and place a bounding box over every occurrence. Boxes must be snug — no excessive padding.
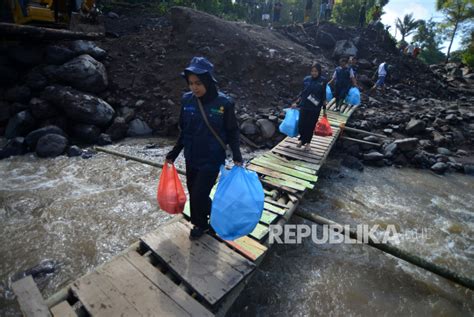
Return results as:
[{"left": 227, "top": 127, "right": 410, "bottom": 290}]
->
[{"left": 141, "top": 222, "right": 253, "bottom": 305}]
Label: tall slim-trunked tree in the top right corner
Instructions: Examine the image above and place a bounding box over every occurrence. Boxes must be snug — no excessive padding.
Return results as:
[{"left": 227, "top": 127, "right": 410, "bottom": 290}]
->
[{"left": 436, "top": 0, "right": 474, "bottom": 62}]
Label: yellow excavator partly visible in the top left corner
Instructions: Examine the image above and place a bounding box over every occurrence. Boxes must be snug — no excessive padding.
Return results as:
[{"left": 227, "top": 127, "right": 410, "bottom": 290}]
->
[{"left": 0, "top": 0, "right": 104, "bottom": 37}]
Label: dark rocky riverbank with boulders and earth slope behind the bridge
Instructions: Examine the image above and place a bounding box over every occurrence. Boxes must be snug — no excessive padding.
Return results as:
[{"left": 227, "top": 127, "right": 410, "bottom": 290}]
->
[{"left": 0, "top": 7, "right": 474, "bottom": 173}]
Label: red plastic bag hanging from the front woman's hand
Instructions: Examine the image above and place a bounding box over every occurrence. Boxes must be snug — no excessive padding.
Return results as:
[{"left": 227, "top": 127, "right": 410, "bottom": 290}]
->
[{"left": 157, "top": 163, "right": 186, "bottom": 214}]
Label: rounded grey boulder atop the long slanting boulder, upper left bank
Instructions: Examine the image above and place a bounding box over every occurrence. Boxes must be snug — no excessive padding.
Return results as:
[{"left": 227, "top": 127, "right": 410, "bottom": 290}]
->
[{"left": 45, "top": 55, "right": 108, "bottom": 93}]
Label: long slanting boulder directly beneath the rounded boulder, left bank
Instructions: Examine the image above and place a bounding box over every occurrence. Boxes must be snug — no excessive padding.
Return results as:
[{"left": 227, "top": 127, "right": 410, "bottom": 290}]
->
[{"left": 42, "top": 86, "right": 115, "bottom": 126}]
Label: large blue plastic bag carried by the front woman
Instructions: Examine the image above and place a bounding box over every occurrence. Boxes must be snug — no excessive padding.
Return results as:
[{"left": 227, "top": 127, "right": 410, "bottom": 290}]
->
[{"left": 211, "top": 166, "right": 265, "bottom": 240}]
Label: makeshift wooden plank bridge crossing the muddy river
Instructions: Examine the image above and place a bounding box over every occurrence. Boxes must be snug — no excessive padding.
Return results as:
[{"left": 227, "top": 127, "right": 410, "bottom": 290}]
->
[{"left": 13, "top": 102, "right": 355, "bottom": 316}]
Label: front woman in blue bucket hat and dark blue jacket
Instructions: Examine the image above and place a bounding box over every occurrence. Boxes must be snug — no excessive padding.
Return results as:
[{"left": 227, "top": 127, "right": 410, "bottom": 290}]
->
[{"left": 166, "top": 57, "right": 242, "bottom": 239}]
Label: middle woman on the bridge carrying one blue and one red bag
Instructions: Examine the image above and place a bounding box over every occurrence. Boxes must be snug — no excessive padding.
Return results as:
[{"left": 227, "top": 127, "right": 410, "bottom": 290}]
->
[{"left": 291, "top": 63, "right": 327, "bottom": 150}]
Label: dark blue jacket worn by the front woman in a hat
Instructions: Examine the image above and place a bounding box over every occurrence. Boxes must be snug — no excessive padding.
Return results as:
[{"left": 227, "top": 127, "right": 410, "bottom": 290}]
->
[{"left": 167, "top": 92, "right": 242, "bottom": 171}]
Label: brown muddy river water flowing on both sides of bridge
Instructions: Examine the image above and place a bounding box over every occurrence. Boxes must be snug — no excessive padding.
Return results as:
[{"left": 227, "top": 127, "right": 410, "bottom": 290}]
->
[{"left": 0, "top": 139, "right": 474, "bottom": 316}]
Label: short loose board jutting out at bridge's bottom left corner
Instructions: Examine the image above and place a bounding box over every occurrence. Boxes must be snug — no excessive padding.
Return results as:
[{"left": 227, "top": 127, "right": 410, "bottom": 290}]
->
[{"left": 12, "top": 275, "right": 51, "bottom": 317}]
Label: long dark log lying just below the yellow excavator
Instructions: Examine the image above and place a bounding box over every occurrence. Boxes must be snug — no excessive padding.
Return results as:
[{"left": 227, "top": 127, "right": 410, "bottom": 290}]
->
[{"left": 0, "top": 22, "right": 104, "bottom": 40}]
